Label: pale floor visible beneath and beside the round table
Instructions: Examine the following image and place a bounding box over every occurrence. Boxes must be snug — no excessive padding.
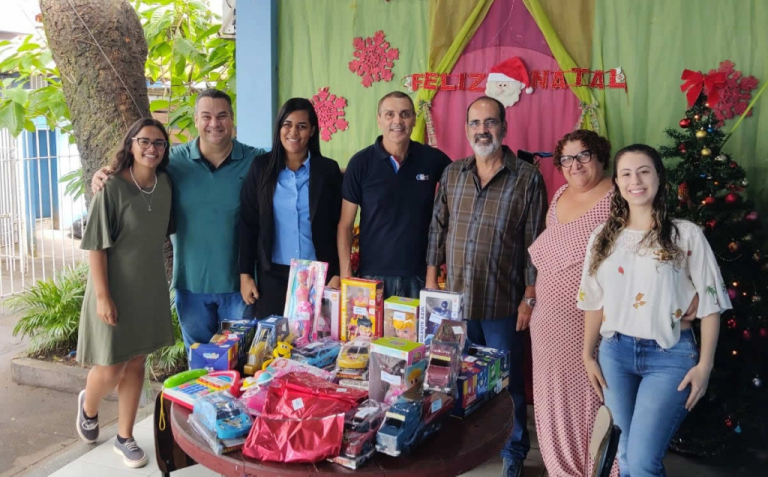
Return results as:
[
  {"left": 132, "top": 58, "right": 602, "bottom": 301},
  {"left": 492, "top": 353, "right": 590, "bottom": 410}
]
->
[{"left": 50, "top": 410, "right": 544, "bottom": 477}]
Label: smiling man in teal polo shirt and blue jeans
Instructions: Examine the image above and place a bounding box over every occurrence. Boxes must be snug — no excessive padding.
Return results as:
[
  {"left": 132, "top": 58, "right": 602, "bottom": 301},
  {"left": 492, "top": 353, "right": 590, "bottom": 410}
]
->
[{"left": 92, "top": 89, "right": 265, "bottom": 354}]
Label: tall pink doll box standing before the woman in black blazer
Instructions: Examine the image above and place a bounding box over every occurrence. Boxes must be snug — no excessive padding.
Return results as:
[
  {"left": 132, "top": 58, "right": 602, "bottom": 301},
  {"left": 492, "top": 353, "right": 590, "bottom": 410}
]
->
[{"left": 283, "top": 258, "right": 328, "bottom": 346}]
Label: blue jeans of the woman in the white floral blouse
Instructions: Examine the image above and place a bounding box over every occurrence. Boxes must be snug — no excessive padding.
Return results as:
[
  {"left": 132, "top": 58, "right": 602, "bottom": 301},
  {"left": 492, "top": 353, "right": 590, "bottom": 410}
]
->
[{"left": 598, "top": 330, "right": 699, "bottom": 477}]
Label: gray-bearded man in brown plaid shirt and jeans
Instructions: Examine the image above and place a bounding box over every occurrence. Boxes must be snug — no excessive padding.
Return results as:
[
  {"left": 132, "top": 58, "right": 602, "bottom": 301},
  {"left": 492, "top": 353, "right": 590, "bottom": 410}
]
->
[{"left": 426, "top": 96, "right": 547, "bottom": 476}]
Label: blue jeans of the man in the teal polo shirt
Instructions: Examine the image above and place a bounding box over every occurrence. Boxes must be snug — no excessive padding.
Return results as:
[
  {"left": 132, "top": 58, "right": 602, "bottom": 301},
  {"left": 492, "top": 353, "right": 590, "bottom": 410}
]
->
[{"left": 176, "top": 288, "right": 253, "bottom": 356}]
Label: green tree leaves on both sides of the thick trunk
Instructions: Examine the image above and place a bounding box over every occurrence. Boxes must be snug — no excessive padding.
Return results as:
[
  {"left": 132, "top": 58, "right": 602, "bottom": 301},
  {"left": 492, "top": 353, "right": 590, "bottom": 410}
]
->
[{"left": 0, "top": 0, "right": 236, "bottom": 192}]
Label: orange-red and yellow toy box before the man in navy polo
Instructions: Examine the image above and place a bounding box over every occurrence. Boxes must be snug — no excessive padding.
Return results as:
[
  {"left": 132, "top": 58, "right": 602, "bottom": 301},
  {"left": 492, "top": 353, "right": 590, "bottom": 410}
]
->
[{"left": 339, "top": 278, "right": 384, "bottom": 341}]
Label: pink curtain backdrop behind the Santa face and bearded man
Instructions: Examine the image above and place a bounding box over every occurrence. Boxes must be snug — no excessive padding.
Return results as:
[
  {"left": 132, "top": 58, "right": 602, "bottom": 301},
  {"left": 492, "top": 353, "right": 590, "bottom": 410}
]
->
[{"left": 432, "top": 0, "right": 580, "bottom": 200}]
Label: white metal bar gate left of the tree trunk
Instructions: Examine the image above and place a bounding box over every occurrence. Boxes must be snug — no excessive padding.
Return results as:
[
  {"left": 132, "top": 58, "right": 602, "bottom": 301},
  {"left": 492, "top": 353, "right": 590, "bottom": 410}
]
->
[{"left": 0, "top": 121, "right": 86, "bottom": 299}]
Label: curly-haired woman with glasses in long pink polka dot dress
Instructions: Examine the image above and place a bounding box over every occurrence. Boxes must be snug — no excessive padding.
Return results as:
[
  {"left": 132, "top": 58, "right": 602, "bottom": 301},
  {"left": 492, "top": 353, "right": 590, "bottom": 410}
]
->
[{"left": 529, "top": 130, "right": 619, "bottom": 477}]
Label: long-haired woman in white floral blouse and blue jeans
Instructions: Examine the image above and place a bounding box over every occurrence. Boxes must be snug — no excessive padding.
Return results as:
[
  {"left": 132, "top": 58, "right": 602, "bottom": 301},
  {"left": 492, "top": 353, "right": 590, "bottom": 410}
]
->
[{"left": 577, "top": 144, "right": 731, "bottom": 477}]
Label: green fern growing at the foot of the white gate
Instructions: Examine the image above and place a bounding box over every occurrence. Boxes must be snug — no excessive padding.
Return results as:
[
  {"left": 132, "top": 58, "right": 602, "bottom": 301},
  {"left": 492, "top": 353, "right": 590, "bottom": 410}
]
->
[{"left": 5, "top": 263, "right": 88, "bottom": 355}]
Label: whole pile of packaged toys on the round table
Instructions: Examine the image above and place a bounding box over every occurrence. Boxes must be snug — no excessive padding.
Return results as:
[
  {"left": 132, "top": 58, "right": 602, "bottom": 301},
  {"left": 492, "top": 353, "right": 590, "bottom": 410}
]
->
[{"left": 164, "top": 260, "right": 509, "bottom": 469}]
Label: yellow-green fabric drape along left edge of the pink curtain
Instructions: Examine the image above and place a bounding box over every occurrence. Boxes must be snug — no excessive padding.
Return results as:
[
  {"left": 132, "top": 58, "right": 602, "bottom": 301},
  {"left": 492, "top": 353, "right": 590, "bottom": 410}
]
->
[{"left": 411, "top": 0, "right": 493, "bottom": 147}]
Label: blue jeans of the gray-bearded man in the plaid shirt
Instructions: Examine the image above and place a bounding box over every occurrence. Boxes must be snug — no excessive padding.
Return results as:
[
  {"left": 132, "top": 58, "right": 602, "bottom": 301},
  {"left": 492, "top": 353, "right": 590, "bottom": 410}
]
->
[{"left": 467, "top": 314, "right": 531, "bottom": 461}]
